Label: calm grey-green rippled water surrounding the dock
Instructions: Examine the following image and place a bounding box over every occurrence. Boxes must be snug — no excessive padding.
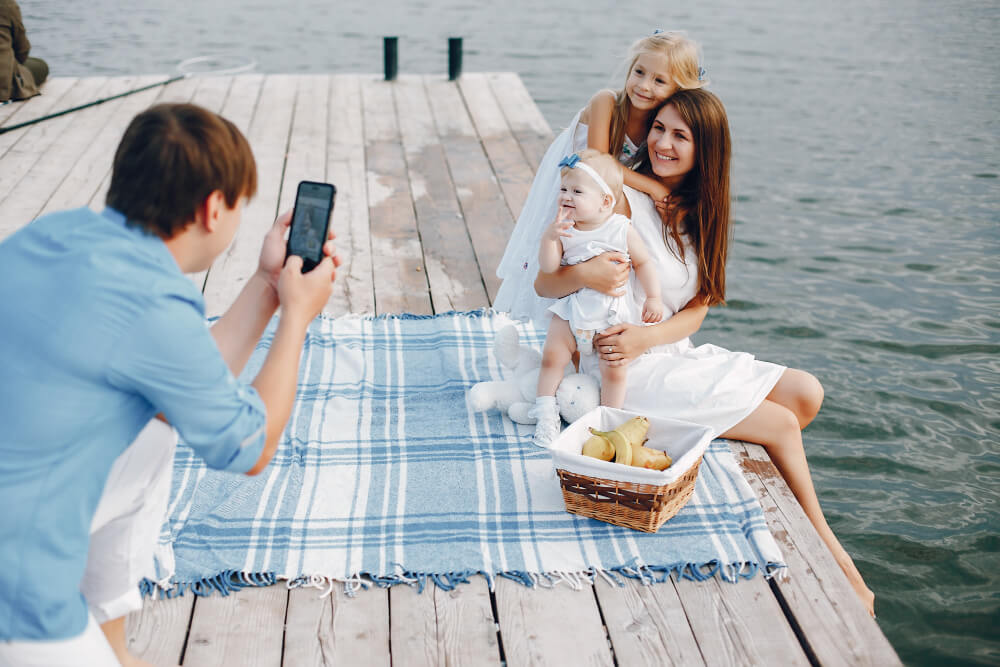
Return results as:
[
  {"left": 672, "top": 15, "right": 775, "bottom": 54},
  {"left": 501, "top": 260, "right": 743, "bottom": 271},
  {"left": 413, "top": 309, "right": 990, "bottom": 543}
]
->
[{"left": 27, "top": 0, "right": 1000, "bottom": 665}]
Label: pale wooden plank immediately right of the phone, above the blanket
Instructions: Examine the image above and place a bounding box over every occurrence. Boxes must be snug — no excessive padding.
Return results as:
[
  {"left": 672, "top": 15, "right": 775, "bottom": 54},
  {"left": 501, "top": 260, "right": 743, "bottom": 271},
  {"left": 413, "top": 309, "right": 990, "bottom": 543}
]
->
[{"left": 326, "top": 74, "right": 375, "bottom": 315}]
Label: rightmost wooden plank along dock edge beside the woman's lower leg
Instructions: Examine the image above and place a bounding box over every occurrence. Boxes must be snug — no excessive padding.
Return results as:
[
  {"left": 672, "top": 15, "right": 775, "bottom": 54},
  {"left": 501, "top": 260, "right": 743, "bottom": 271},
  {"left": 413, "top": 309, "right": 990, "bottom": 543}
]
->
[{"left": 730, "top": 441, "right": 901, "bottom": 666}]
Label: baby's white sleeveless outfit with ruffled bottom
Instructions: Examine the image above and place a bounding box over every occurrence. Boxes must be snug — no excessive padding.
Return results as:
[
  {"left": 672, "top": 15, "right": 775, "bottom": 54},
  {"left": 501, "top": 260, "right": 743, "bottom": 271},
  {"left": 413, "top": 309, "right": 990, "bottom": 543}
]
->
[{"left": 549, "top": 213, "right": 642, "bottom": 342}]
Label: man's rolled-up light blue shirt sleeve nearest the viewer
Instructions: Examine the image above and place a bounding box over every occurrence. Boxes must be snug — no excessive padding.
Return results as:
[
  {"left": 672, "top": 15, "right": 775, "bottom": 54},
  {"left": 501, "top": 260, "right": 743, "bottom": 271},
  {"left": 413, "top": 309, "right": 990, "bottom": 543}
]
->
[{"left": 108, "top": 298, "right": 267, "bottom": 472}]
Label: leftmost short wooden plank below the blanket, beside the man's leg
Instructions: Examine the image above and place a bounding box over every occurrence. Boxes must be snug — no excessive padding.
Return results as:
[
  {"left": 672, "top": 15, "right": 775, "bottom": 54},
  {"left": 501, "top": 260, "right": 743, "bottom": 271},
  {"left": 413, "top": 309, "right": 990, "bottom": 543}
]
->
[{"left": 125, "top": 594, "right": 195, "bottom": 665}]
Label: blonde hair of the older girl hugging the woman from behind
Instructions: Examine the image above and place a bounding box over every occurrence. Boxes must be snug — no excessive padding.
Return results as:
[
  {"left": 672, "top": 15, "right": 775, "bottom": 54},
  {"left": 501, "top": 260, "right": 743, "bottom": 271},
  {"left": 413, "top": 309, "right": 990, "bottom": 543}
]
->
[{"left": 608, "top": 32, "right": 708, "bottom": 160}]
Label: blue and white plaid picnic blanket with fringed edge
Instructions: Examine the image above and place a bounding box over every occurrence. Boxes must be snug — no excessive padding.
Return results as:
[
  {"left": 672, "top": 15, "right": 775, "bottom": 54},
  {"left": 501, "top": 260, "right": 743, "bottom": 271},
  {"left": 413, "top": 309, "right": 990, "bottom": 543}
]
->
[{"left": 143, "top": 310, "right": 781, "bottom": 595}]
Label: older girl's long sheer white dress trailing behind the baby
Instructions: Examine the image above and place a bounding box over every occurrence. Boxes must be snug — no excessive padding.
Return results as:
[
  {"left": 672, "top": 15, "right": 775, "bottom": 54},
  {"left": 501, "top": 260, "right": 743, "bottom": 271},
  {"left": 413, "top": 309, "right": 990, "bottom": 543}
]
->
[{"left": 493, "top": 111, "right": 637, "bottom": 328}]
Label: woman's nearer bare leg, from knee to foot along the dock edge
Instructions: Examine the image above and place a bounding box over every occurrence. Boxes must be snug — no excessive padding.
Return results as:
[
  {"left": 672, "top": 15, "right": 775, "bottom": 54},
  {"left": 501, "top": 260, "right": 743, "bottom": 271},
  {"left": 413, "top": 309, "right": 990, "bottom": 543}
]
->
[{"left": 722, "top": 396, "right": 875, "bottom": 616}]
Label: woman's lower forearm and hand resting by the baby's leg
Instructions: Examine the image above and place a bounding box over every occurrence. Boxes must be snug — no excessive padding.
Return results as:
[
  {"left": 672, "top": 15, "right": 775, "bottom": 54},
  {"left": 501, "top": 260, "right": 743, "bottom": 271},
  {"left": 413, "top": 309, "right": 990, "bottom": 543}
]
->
[{"left": 594, "top": 294, "right": 708, "bottom": 366}]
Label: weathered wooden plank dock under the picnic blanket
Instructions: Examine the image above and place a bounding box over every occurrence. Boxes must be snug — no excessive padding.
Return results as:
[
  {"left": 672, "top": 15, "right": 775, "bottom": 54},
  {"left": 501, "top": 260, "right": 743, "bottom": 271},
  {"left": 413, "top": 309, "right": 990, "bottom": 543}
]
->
[{"left": 0, "top": 73, "right": 900, "bottom": 667}]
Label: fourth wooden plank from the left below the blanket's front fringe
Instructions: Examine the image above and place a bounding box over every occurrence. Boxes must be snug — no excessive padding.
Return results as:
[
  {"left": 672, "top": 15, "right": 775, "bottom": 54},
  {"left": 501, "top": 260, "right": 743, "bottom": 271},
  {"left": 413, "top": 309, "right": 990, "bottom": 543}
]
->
[{"left": 389, "top": 576, "right": 500, "bottom": 667}]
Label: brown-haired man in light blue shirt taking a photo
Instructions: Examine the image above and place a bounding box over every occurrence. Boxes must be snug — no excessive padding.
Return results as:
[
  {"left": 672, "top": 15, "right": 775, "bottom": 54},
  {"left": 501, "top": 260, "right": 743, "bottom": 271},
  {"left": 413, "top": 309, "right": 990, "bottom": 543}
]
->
[{"left": 0, "top": 104, "right": 339, "bottom": 665}]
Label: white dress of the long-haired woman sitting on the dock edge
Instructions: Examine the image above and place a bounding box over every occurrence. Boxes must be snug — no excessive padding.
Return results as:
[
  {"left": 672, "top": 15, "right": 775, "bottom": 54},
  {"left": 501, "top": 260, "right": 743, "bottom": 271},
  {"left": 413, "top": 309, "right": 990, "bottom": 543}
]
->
[{"left": 580, "top": 186, "right": 785, "bottom": 435}]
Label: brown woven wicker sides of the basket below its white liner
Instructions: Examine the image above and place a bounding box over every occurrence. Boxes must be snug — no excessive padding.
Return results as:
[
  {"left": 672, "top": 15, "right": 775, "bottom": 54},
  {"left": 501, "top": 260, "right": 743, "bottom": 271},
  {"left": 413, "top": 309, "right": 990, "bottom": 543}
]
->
[{"left": 556, "top": 457, "right": 701, "bottom": 533}]
